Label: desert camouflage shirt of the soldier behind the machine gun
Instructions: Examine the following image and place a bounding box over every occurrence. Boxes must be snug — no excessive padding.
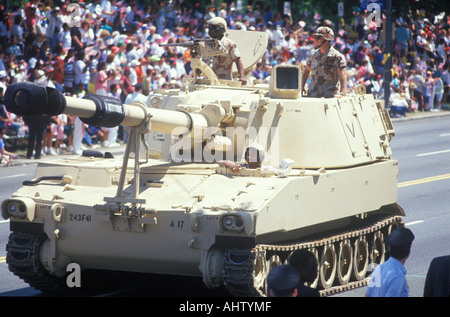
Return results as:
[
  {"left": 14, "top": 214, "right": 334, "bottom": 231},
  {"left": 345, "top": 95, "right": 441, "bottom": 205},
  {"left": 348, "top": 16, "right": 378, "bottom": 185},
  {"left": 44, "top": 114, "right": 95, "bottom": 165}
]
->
[{"left": 207, "top": 37, "right": 241, "bottom": 80}]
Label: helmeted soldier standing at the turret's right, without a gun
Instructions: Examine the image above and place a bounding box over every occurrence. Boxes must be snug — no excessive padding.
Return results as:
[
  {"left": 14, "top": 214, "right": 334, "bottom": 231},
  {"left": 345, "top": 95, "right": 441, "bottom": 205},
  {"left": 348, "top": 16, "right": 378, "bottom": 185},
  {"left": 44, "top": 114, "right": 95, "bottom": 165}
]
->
[{"left": 302, "top": 26, "right": 347, "bottom": 98}]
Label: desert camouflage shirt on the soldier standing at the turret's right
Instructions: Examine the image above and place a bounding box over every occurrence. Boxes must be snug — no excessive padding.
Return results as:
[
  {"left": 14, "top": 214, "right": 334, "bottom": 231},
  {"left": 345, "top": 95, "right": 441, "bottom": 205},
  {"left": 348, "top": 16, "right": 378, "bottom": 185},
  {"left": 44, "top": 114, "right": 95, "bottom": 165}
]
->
[{"left": 306, "top": 47, "right": 347, "bottom": 98}]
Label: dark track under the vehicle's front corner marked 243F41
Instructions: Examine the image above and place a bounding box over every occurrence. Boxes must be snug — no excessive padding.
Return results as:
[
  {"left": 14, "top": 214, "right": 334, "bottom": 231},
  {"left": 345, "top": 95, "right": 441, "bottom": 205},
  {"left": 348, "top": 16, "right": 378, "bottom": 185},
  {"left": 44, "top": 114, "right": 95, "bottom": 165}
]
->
[{"left": 6, "top": 232, "right": 66, "bottom": 294}]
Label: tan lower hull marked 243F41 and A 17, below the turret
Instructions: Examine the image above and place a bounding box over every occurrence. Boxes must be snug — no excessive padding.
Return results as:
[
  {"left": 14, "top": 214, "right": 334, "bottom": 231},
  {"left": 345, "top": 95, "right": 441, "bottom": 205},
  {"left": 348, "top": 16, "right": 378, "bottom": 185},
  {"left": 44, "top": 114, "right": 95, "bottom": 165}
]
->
[{"left": 3, "top": 152, "right": 401, "bottom": 295}]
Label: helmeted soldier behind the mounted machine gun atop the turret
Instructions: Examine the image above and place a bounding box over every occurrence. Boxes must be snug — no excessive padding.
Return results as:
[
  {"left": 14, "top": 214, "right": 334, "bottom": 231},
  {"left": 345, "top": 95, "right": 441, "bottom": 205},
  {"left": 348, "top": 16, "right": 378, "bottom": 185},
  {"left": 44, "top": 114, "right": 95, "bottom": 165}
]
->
[{"left": 208, "top": 17, "right": 247, "bottom": 85}]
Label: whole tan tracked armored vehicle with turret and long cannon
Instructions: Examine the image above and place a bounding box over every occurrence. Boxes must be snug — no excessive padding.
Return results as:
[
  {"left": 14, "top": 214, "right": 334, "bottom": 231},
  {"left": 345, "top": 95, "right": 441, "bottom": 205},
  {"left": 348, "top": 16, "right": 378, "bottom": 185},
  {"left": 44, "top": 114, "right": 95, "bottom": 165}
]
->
[{"left": 2, "top": 32, "right": 404, "bottom": 296}]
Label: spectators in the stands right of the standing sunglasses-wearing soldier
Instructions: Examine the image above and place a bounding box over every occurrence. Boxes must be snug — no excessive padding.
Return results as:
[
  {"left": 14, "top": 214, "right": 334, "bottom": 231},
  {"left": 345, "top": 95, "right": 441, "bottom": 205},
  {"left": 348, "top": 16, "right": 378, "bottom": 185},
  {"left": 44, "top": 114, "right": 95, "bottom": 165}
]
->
[{"left": 342, "top": 10, "right": 450, "bottom": 117}]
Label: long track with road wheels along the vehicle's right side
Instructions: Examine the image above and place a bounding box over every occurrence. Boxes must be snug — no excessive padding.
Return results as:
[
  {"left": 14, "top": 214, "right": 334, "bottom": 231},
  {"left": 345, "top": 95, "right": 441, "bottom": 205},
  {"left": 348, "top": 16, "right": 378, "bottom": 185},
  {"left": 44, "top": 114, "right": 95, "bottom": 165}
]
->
[{"left": 222, "top": 216, "right": 404, "bottom": 296}]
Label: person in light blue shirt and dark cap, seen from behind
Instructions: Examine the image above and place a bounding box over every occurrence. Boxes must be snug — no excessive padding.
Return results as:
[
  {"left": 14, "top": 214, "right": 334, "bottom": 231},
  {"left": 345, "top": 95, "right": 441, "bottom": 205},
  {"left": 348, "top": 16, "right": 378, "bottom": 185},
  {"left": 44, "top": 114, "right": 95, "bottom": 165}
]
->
[{"left": 366, "top": 228, "right": 414, "bottom": 297}]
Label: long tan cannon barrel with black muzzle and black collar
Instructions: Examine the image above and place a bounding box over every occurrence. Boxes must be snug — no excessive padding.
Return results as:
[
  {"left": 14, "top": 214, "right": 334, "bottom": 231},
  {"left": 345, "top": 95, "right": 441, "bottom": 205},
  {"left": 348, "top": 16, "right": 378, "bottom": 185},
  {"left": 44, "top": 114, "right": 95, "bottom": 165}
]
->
[{"left": 5, "top": 82, "right": 208, "bottom": 133}]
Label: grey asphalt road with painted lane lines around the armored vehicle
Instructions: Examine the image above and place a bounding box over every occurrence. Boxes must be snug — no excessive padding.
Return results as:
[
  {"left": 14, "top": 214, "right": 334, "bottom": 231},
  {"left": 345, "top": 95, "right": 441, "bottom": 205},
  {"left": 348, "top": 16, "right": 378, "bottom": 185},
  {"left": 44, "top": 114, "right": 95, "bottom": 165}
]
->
[{"left": 0, "top": 116, "right": 450, "bottom": 297}]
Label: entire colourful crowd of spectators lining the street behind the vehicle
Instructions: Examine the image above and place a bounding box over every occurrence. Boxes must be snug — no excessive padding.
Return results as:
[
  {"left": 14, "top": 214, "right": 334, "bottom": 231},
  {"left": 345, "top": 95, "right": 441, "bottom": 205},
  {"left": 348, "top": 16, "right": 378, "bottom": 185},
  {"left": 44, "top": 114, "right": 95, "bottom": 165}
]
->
[{"left": 0, "top": 0, "right": 450, "bottom": 160}]
